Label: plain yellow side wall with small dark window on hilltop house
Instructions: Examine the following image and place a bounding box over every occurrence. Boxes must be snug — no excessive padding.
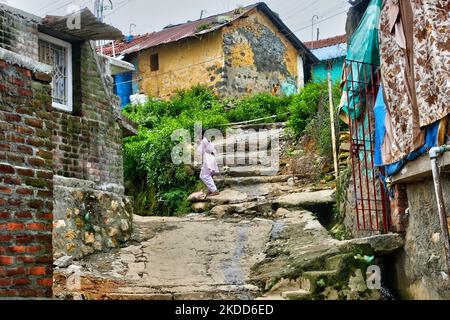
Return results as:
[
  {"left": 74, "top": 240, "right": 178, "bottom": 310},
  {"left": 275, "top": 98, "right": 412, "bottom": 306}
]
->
[{"left": 138, "top": 31, "right": 224, "bottom": 98}]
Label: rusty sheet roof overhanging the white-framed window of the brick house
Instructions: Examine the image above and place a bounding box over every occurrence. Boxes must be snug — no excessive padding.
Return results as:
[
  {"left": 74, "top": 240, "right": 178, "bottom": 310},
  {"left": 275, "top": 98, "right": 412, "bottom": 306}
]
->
[{"left": 39, "top": 8, "right": 123, "bottom": 41}]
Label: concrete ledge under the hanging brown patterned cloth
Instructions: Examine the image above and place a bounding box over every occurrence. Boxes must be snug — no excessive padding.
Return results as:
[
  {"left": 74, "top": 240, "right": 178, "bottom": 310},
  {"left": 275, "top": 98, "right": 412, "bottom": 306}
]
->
[{"left": 392, "top": 152, "right": 450, "bottom": 184}]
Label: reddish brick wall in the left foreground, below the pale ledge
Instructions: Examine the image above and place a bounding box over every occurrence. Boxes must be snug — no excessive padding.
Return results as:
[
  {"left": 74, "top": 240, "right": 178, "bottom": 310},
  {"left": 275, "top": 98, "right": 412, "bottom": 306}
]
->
[{"left": 0, "top": 60, "right": 53, "bottom": 297}]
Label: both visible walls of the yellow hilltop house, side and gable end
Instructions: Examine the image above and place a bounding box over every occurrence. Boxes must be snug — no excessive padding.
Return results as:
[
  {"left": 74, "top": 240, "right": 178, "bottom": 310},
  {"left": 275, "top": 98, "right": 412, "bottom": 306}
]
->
[{"left": 137, "top": 9, "right": 298, "bottom": 98}]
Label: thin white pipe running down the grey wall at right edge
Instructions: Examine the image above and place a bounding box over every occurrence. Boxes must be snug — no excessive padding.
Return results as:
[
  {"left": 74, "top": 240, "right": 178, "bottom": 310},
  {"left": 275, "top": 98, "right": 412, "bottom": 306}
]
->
[{"left": 430, "top": 145, "right": 450, "bottom": 275}]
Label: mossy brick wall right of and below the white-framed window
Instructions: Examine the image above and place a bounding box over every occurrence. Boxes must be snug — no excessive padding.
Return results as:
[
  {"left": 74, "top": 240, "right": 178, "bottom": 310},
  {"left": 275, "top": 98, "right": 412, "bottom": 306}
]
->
[{"left": 53, "top": 43, "right": 123, "bottom": 186}]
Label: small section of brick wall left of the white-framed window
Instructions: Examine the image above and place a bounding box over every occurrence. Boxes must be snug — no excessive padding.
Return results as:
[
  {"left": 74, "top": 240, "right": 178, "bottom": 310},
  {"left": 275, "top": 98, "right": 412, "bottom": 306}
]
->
[{"left": 0, "top": 3, "right": 39, "bottom": 59}]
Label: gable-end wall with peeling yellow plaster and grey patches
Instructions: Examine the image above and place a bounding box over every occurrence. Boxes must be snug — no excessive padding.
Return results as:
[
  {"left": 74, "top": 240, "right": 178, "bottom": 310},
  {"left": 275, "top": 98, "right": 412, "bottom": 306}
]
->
[{"left": 218, "top": 9, "right": 298, "bottom": 97}]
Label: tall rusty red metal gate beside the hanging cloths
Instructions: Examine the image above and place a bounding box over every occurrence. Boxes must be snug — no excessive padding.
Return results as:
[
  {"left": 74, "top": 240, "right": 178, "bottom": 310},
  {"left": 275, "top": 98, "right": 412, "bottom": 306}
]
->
[{"left": 344, "top": 60, "right": 392, "bottom": 233}]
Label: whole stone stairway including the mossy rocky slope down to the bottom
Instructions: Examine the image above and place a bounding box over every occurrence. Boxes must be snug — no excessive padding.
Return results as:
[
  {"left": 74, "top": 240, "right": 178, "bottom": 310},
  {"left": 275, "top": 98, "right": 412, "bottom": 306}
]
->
[{"left": 190, "top": 126, "right": 401, "bottom": 300}]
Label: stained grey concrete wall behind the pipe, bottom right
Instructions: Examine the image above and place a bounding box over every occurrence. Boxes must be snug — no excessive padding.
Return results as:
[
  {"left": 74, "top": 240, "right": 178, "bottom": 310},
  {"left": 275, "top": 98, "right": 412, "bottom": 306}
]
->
[{"left": 396, "top": 174, "right": 450, "bottom": 299}]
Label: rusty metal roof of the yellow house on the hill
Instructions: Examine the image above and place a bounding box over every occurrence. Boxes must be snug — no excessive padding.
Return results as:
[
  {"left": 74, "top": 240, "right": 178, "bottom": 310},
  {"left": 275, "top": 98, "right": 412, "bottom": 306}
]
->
[{"left": 103, "top": 2, "right": 318, "bottom": 63}]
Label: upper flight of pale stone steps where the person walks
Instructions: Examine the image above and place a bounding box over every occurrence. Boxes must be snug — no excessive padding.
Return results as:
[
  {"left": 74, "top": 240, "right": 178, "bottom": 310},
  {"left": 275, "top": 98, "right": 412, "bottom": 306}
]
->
[{"left": 190, "top": 124, "right": 334, "bottom": 218}]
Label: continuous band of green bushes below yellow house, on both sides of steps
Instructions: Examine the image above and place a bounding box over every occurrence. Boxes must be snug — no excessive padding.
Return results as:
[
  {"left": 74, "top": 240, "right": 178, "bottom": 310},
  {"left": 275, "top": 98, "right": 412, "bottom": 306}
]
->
[{"left": 123, "top": 83, "right": 342, "bottom": 215}]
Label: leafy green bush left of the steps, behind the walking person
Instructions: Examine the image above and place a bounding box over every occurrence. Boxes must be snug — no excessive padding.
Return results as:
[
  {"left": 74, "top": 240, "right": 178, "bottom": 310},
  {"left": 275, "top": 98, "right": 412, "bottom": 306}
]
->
[{"left": 123, "top": 87, "right": 228, "bottom": 215}]
